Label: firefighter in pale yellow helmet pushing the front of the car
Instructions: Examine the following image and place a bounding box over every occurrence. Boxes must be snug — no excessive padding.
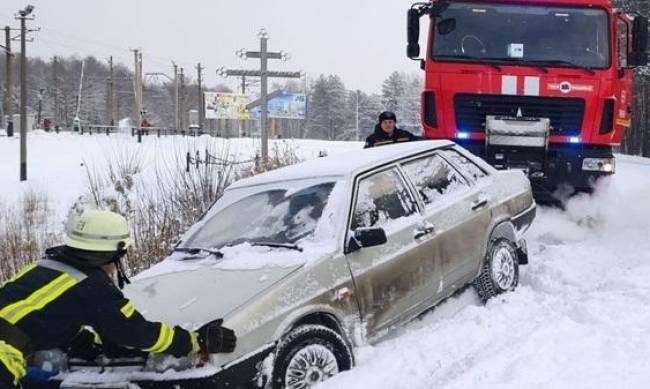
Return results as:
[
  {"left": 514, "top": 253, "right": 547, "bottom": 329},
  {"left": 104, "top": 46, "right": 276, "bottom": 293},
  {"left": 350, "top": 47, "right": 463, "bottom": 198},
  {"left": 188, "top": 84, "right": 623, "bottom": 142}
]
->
[{"left": 0, "top": 211, "right": 237, "bottom": 389}]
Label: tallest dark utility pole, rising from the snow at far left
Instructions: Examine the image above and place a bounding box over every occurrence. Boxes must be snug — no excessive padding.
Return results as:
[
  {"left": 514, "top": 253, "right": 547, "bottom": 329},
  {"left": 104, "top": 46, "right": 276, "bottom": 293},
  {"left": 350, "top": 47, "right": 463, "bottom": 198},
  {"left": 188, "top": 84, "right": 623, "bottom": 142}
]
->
[{"left": 16, "top": 5, "right": 34, "bottom": 181}]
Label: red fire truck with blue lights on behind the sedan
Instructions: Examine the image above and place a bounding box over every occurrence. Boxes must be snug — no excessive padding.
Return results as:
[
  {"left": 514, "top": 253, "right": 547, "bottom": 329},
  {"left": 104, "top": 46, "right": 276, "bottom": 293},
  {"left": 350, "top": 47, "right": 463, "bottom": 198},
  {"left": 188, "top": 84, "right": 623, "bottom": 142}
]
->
[{"left": 407, "top": 0, "right": 648, "bottom": 198}]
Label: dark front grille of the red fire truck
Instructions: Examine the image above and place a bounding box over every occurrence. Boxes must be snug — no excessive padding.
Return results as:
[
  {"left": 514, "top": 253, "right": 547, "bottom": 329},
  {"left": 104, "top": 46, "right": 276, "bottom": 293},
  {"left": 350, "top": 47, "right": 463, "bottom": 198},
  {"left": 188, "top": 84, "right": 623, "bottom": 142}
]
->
[{"left": 454, "top": 94, "right": 585, "bottom": 136}]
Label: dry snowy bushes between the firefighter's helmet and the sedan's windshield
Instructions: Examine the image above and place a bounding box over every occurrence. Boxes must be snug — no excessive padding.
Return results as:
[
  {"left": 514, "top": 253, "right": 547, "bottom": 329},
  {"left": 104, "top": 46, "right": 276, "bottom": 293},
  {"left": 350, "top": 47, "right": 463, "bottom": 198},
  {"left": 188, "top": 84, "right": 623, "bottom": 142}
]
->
[{"left": 79, "top": 142, "right": 300, "bottom": 274}]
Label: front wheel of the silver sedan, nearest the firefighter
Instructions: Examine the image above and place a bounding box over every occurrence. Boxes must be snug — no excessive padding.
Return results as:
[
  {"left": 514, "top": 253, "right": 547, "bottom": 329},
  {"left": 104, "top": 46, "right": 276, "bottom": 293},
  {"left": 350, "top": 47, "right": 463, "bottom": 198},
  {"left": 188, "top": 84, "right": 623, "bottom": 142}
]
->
[{"left": 272, "top": 325, "right": 353, "bottom": 389}]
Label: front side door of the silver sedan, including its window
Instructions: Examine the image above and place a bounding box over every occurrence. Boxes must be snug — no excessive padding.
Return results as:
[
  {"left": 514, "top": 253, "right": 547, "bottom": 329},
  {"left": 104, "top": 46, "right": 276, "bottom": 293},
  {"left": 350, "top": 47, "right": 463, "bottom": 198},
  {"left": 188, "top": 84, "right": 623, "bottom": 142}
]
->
[{"left": 346, "top": 166, "right": 427, "bottom": 337}]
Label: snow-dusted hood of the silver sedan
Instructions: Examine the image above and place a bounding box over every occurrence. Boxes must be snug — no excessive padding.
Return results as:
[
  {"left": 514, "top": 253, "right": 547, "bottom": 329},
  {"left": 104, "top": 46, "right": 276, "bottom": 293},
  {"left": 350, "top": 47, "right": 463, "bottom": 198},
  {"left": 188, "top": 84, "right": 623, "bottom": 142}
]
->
[{"left": 124, "top": 260, "right": 302, "bottom": 329}]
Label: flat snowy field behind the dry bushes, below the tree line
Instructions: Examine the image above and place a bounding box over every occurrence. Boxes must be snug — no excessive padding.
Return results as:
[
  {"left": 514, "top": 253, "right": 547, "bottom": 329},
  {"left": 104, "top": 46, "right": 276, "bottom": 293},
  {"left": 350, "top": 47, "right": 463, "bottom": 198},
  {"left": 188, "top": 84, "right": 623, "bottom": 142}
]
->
[{"left": 0, "top": 131, "right": 362, "bottom": 220}]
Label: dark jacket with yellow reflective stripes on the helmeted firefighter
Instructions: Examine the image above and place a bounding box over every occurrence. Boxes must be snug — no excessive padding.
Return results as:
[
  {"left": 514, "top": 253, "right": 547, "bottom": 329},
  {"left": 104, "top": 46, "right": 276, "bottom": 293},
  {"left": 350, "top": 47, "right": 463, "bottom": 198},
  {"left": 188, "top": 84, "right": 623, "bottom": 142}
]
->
[{"left": 0, "top": 248, "right": 194, "bottom": 357}]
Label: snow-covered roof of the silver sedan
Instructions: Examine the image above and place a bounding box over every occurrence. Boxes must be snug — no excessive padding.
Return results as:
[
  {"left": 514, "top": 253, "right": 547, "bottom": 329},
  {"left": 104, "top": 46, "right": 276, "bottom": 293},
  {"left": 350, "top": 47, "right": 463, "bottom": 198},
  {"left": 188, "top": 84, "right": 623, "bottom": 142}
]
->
[{"left": 228, "top": 140, "right": 454, "bottom": 190}]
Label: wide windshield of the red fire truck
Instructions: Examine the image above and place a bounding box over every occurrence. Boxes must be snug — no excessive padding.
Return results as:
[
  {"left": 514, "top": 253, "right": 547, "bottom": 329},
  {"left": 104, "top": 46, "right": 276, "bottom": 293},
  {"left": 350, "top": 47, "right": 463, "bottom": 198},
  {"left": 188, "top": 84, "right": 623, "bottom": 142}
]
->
[{"left": 432, "top": 2, "right": 610, "bottom": 69}]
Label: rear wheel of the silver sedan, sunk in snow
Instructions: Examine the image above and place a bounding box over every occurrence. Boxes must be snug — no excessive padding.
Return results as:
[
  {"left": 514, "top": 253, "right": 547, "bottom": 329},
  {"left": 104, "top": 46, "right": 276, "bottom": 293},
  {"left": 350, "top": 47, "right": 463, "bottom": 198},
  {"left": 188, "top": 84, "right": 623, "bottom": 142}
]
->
[{"left": 474, "top": 239, "right": 519, "bottom": 301}]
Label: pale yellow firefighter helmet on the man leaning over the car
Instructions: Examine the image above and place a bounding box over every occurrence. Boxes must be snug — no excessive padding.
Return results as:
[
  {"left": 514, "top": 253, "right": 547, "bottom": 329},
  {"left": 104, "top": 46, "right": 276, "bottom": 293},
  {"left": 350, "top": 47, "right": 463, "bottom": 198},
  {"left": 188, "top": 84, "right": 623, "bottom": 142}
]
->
[{"left": 64, "top": 210, "right": 133, "bottom": 252}]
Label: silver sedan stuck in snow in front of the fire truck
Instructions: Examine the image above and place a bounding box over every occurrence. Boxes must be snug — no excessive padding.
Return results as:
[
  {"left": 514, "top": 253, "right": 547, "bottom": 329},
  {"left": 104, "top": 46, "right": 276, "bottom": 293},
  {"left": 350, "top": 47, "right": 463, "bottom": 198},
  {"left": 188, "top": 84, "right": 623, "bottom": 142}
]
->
[{"left": 55, "top": 141, "right": 535, "bottom": 388}]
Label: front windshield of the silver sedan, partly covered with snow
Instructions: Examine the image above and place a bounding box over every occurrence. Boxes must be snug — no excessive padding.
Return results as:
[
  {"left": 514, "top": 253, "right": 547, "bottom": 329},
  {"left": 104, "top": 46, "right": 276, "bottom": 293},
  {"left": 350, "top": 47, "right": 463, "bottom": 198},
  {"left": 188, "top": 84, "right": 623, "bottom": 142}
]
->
[{"left": 182, "top": 182, "right": 335, "bottom": 248}]
